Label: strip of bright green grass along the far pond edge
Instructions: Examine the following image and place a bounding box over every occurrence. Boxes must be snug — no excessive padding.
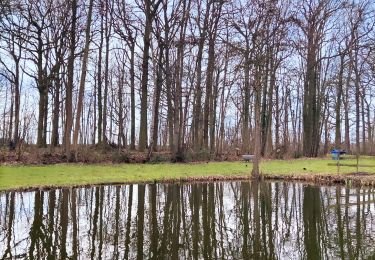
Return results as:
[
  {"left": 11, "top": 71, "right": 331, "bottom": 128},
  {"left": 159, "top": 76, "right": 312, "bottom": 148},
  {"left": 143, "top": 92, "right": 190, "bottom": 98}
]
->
[{"left": 0, "top": 157, "right": 375, "bottom": 190}]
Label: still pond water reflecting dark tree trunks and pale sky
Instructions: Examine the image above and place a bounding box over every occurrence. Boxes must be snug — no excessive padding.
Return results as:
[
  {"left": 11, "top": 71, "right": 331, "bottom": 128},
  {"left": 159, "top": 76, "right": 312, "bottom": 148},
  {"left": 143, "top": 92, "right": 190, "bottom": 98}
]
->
[{"left": 0, "top": 182, "right": 375, "bottom": 259}]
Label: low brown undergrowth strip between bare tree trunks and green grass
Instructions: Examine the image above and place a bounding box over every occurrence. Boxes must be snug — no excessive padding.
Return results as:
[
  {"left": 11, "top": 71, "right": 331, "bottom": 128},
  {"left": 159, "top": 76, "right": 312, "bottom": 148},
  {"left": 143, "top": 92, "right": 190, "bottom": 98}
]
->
[{"left": 0, "top": 144, "right": 245, "bottom": 165}]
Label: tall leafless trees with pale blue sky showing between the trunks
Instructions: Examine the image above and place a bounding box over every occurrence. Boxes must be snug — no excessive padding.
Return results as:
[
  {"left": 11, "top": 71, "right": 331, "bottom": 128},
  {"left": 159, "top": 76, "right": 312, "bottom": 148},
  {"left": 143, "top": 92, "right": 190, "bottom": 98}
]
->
[{"left": 0, "top": 0, "right": 375, "bottom": 160}]
